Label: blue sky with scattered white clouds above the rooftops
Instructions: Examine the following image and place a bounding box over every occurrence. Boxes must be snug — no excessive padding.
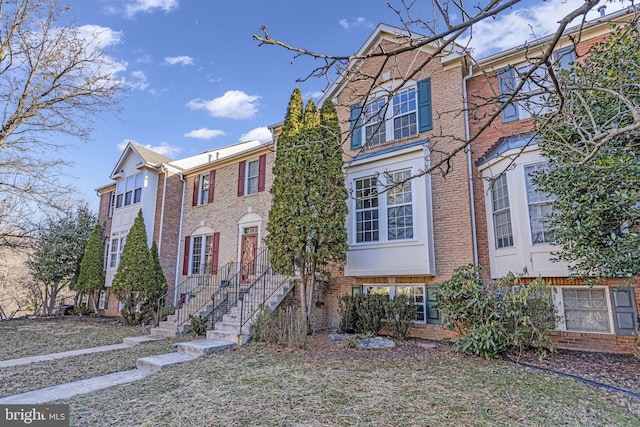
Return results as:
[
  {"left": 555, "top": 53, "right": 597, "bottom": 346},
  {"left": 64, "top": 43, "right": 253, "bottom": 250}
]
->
[{"left": 61, "top": 0, "right": 628, "bottom": 209}]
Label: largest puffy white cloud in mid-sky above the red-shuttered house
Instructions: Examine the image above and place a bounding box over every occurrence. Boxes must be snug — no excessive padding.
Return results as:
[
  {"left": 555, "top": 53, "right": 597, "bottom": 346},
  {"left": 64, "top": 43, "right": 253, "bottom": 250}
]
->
[{"left": 187, "top": 90, "right": 260, "bottom": 119}]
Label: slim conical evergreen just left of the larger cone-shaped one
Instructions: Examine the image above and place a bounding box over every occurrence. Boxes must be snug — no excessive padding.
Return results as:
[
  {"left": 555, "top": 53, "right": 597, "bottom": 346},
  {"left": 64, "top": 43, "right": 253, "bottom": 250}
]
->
[{"left": 73, "top": 224, "right": 104, "bottom": 313}]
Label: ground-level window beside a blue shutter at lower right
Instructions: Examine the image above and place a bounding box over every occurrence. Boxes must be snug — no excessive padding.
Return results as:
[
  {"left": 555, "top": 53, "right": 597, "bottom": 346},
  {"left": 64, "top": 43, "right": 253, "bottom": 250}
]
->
[{"left": 556, "top": 286, "right": 611, "bottom": 333}]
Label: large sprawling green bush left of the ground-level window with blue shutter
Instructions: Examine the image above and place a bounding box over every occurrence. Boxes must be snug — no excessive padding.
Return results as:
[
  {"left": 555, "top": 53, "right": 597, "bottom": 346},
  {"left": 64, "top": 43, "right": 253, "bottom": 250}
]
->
[{"left": 436, "top": 265, "right": 556, "bottom": 359}]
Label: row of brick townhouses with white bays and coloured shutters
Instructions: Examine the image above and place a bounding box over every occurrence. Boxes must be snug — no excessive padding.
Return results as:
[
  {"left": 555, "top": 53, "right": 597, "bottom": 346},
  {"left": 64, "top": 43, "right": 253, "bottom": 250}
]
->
[{"left": 92, "top": 13, "right": 640, "bottom": 352}]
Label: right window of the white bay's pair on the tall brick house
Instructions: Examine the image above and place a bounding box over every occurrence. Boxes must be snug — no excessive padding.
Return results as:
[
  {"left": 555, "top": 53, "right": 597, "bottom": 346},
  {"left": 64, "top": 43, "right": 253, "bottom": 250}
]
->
[{"left": 387, "top": 170, "right": 413, "bottom": 240}]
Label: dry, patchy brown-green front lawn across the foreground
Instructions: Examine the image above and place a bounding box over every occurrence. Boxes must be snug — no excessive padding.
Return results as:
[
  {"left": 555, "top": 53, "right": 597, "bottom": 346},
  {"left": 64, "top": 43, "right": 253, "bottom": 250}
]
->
[{"left": 0, "top": 318, "right": 640, "bottom": 427}]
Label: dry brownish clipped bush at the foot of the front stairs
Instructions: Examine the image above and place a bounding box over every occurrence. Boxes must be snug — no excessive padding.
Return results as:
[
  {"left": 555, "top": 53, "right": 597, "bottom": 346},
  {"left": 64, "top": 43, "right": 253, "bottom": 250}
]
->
[{"left": 252, "top": 306, "right": 308, "bottom": 348}]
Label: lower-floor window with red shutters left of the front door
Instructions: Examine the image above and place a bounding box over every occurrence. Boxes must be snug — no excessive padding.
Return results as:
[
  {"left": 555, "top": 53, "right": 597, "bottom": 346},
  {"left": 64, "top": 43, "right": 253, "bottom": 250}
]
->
[{"left": 182, "top": 233, "right": 220, "bottom": 275}]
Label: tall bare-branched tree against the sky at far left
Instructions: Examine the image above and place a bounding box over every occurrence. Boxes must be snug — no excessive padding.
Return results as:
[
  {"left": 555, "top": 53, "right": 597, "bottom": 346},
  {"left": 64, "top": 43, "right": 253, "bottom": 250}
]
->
[{"left": 0, "top": 0, "right": 121, "bottom": 249}]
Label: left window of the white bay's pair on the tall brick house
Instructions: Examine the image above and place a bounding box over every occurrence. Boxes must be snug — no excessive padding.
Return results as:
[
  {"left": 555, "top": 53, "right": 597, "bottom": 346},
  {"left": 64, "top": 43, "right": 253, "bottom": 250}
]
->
[{"left": 355, "top": 176, "right": 380, "bottom": 243}]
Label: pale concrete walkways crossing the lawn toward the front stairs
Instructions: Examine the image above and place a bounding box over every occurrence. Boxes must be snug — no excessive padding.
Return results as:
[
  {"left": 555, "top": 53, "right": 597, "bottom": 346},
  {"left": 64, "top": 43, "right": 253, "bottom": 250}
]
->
[{"left": 0, "top": 335, "right": 234, "bottom": 404}]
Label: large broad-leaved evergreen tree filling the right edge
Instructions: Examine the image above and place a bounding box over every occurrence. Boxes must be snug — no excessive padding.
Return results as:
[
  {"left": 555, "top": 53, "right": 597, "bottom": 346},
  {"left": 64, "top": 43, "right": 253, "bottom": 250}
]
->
[{"left": 534, "top": 24, "right": 640, "bottom": 280}]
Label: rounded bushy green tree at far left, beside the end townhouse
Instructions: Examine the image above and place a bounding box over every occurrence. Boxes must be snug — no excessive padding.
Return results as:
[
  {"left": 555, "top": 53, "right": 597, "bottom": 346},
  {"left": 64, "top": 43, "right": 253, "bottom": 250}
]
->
[{"left": 27, "top": 206, "right": 97, "bottom": 315}]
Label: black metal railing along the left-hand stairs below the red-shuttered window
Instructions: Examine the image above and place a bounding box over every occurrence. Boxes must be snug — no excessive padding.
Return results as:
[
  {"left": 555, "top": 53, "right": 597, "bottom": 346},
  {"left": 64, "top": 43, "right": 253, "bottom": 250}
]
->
[{"left": 156, "top": 263, "right": 235, "bottom": 327}]
